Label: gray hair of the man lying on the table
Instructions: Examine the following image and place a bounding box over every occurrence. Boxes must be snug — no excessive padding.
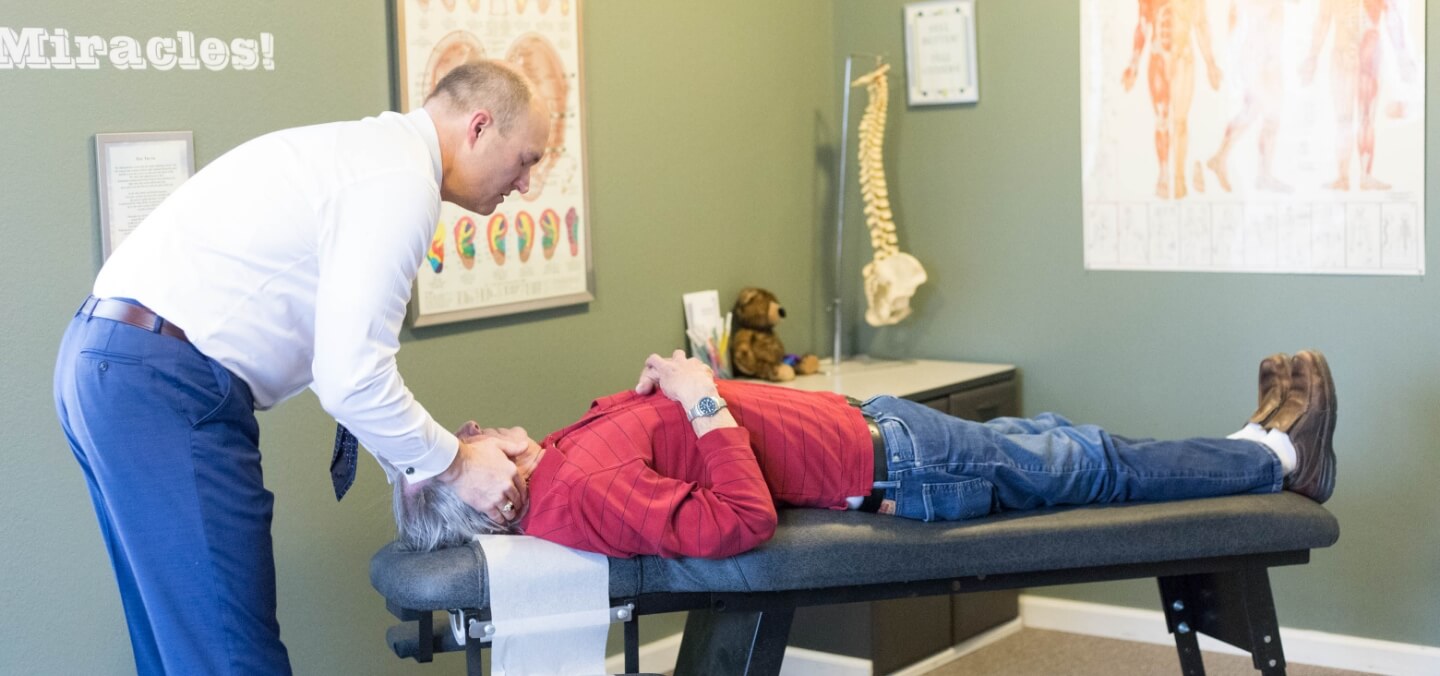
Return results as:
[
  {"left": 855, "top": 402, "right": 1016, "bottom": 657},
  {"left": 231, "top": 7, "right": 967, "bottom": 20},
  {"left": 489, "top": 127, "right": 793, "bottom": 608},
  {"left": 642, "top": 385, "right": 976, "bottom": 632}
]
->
[{"left": 386, "top": 467, "right": 518, "bottom": 552}]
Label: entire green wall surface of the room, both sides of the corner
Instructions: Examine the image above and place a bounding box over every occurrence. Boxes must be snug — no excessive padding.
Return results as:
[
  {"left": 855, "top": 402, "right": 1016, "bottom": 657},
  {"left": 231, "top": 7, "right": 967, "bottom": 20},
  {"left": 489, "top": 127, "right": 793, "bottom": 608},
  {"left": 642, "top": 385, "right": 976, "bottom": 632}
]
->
[{"left": 0, "top": 0, "right": 1440, "bottom": 673}]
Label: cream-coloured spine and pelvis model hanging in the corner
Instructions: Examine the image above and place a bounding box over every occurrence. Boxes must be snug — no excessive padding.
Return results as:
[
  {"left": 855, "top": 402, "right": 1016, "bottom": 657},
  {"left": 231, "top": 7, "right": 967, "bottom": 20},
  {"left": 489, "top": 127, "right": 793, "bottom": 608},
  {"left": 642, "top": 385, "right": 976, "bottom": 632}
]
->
[{"left": 850, "top": 63, "right": 926, "bottom": 326}]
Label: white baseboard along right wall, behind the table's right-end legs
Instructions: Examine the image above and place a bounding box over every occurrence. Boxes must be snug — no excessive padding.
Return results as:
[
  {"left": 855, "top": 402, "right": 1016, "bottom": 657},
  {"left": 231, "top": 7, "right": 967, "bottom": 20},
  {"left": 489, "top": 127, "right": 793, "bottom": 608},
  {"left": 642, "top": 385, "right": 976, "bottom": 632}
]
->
[{"left": 1020, "top": 594, "right": 1440, "bottom": 676}]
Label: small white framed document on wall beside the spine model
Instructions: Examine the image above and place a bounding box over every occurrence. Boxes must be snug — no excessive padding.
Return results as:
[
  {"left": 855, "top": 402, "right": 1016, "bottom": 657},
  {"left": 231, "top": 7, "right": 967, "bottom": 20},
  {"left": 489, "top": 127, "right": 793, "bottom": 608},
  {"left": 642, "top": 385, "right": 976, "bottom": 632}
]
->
[{"left": 904, "top": 0, "right": 981, "bottom": 105}]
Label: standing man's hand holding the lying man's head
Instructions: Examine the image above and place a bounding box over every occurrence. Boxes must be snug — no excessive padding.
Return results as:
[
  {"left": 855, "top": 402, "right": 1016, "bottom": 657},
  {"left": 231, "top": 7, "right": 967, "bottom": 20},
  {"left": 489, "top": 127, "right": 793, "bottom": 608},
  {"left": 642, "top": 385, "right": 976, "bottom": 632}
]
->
[{"left": 435, "top": 422, "right": 527, "bottom": 523}]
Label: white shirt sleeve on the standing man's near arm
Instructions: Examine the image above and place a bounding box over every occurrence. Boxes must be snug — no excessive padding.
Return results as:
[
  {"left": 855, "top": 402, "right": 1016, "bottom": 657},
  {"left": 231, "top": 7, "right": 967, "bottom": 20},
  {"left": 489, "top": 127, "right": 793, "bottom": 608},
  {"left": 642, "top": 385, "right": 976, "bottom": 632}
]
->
[{"left": 311, "top": 172, "right": 459, "bottom": 481}]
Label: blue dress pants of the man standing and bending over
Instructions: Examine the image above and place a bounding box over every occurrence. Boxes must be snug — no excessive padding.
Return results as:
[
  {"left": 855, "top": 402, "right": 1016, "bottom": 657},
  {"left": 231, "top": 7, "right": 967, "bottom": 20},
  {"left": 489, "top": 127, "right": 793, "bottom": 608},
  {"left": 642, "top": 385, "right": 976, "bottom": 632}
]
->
[{"left": 55, "top": 307, "right": 289, "bottom": 676}]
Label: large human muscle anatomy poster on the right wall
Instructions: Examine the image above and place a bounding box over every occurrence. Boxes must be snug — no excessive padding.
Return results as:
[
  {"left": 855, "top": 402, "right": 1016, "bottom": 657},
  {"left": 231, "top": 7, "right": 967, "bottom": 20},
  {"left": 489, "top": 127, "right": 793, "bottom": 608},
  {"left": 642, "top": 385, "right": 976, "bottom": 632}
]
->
[{"left": 1080, "top": 0, "right": 1426, "bottom": 275}]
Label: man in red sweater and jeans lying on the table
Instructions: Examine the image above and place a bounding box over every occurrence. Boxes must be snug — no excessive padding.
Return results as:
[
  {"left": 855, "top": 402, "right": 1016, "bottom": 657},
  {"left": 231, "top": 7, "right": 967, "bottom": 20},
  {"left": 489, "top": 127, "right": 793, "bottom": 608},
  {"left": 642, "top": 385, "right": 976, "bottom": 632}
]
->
[{"left": 395, "top": 350, "right": 1335, "bottom": 558}]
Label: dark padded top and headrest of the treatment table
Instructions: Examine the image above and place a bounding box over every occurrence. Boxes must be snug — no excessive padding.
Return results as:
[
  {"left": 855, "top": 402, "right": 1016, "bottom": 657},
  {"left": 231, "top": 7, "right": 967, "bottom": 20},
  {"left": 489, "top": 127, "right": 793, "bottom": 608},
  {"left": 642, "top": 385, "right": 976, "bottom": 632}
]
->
[{"left": 370, "top": 493, "right": 1339, "bottom": 610}]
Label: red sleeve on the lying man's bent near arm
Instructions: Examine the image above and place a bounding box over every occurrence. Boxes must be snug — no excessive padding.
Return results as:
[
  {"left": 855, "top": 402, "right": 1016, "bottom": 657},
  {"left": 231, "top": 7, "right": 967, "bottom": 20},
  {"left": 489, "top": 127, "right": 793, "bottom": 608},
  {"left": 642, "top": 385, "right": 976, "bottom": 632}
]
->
[{"left": 570, "top": 428, "right": 776, "bottom": 559}]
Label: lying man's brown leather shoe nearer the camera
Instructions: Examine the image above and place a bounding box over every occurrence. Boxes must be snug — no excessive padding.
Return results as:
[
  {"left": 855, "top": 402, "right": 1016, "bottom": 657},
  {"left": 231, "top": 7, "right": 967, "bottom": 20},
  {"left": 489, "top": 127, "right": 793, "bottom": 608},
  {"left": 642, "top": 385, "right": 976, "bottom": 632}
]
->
[{"left": 1264, "top": 350, "right": 1335, "bottom": 503}]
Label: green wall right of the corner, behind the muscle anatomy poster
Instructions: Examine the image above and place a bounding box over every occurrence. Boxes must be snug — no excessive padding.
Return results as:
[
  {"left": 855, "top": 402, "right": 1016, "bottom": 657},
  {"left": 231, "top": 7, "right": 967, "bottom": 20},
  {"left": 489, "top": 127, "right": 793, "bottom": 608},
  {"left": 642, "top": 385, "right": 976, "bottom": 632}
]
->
[{"left": 834, "top": 0, "right": 1440, "bottom": 646}]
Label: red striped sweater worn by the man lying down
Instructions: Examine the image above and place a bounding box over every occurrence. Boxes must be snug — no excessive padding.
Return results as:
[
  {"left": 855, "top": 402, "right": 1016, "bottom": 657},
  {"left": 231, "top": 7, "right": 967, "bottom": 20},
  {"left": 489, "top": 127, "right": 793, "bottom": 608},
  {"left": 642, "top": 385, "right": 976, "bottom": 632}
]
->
[{"left": 520, "top": 381, "right": 874, "bottom": 558}]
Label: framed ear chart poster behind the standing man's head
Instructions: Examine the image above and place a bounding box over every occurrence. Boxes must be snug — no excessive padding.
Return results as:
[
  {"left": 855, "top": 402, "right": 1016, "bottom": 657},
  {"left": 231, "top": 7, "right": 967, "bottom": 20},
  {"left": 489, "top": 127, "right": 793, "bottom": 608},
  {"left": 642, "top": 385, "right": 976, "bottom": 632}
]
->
[{"left": 393, "top": 0, "right": 595, "bottom": 327}]
